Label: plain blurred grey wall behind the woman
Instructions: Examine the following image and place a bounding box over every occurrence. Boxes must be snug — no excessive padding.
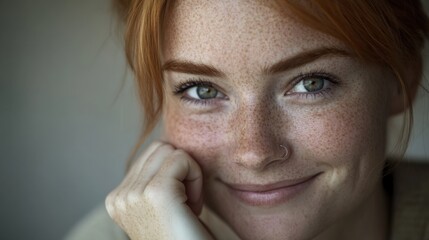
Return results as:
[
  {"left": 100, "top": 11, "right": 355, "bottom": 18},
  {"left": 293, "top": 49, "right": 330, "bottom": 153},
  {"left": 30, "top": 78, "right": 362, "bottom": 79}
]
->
[{"left": 0, "top": 0, "right": 429, "bottom": 239}]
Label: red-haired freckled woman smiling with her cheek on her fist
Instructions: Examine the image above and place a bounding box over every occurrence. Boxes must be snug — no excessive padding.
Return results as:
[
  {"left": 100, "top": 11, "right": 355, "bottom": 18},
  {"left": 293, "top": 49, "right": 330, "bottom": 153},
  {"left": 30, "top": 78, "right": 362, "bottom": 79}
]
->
[{"left": 64, "top": 0, "right": 429, "bottom": 240}]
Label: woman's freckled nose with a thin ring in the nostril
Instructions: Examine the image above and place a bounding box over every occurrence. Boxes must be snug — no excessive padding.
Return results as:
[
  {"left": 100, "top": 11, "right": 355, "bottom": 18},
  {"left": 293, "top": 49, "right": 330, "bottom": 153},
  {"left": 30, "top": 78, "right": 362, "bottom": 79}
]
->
[{"left": 231, "top": 99, "right": 287, "bottom": 171}]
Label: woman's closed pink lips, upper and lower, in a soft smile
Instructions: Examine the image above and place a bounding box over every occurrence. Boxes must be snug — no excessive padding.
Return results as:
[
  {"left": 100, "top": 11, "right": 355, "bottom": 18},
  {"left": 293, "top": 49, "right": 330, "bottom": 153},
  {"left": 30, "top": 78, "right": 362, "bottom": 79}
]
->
[{"left": 225, "top": 173, "right": 320, "bottom": 207}]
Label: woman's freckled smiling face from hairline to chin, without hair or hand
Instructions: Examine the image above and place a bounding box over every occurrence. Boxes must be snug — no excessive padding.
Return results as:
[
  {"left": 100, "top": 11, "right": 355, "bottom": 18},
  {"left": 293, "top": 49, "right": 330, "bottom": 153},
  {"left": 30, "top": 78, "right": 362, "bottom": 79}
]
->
[{"left": 163, "top": 0, "right": 394, "bottom": 239}]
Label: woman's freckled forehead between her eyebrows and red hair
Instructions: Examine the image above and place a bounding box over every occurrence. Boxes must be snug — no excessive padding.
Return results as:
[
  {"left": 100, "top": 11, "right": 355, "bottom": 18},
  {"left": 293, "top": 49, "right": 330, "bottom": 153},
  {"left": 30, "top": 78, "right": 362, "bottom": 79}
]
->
[{"left": 163, "top": 0, "right": 344, "bottom": 73}]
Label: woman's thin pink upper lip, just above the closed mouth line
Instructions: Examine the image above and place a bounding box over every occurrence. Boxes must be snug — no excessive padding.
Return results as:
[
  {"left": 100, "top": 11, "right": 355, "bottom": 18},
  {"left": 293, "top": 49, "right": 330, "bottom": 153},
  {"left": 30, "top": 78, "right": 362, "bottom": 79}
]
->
[{"left": 225, "top": 173, "right": 319, "bottom": 192}]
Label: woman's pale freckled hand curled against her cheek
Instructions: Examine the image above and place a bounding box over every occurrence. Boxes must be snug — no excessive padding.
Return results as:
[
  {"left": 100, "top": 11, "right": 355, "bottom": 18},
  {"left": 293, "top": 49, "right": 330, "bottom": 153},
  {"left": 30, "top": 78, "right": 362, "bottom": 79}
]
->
[{"left": 106, "top": 142, "right": 213, "bottom": 240}]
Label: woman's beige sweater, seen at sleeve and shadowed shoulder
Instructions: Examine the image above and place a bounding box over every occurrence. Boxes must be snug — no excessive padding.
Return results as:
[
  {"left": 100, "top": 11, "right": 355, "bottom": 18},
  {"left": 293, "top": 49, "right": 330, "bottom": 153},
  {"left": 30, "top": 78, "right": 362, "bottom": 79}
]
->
[{"left": 65, "top": 162, "right": 429, "bottom": 240}]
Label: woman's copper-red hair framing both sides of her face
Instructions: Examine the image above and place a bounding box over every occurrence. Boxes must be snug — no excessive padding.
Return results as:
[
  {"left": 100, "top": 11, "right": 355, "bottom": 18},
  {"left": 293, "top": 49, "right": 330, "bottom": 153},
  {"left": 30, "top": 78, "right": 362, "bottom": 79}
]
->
[{"left": 114, "top": 0, "right": 429, "bottom": 169}]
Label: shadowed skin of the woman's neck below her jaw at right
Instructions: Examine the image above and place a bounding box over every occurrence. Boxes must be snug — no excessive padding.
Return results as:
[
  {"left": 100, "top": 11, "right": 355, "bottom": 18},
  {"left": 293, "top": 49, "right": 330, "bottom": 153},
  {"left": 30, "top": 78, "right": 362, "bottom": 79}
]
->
[{"left": 316, "top": 182, "right": 389, "bottom": 240}]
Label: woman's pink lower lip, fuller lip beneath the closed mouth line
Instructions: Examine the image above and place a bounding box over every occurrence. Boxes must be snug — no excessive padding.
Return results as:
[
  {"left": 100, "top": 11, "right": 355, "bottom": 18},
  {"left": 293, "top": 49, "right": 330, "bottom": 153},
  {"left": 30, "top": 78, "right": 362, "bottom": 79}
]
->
[{"left": 228, "top": 174, "right": 318, "bottom": 207}]
